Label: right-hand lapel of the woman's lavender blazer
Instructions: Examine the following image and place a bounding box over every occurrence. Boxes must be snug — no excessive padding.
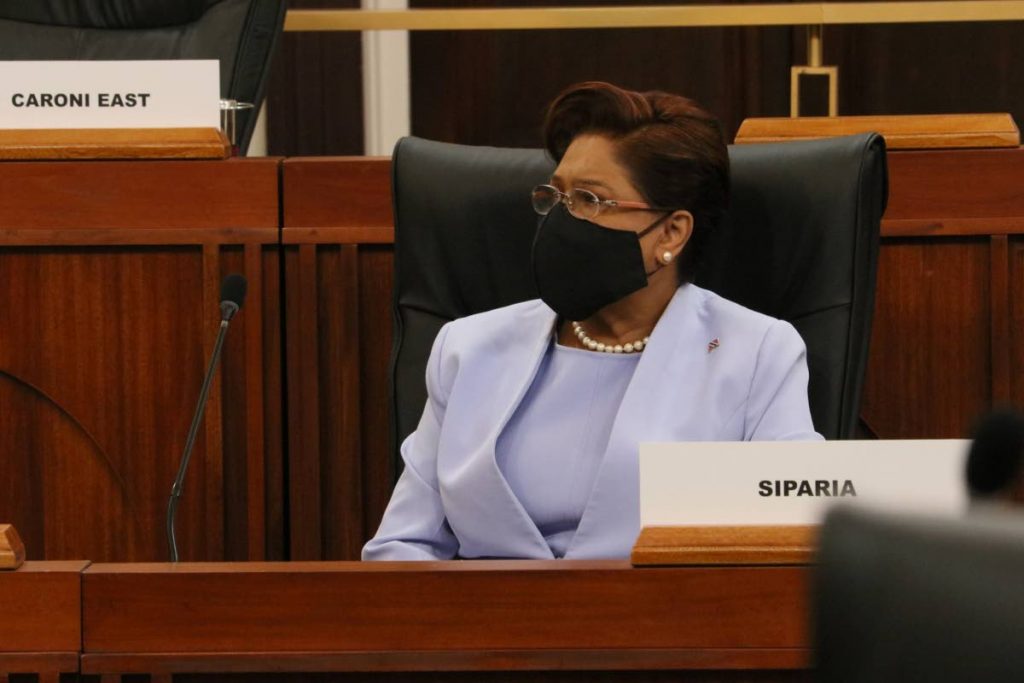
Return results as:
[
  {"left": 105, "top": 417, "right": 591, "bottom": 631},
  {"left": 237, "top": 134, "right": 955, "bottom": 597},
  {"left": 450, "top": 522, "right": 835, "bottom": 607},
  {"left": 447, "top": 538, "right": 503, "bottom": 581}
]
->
[{"left": 566, "top": 285, "right": 708, "bottom": 558}]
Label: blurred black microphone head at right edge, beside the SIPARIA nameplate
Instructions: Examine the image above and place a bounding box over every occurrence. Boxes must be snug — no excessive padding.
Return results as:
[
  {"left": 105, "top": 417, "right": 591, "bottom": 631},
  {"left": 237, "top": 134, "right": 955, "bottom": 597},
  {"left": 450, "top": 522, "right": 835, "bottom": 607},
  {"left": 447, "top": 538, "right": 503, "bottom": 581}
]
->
[{"left": 967, "top": 409, "right": 1024, "bottom": 498}]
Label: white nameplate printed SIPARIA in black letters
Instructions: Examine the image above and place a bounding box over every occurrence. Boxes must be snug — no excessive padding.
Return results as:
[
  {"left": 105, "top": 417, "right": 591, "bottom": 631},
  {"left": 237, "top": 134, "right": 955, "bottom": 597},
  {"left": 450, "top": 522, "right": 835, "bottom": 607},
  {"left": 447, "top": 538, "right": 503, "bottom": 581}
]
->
[{"left": 640, "top": 439, "right": 971, "bottom": 526}]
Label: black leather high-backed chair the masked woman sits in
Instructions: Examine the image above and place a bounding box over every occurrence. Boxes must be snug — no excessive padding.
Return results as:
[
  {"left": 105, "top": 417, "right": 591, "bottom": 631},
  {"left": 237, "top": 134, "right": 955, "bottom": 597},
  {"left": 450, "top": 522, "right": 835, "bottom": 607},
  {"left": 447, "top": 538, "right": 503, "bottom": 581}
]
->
[{"left": 391, "top": 134, "right": 888, "bottom": 465}]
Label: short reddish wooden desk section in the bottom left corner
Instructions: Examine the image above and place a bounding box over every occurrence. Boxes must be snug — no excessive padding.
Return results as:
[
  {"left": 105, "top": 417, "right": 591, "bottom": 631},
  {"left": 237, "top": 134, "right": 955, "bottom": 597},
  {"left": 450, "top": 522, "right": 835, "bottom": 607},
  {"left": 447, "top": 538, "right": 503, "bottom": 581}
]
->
[{"left": 0, "top": 561, "right": 89, "bottom": 683}]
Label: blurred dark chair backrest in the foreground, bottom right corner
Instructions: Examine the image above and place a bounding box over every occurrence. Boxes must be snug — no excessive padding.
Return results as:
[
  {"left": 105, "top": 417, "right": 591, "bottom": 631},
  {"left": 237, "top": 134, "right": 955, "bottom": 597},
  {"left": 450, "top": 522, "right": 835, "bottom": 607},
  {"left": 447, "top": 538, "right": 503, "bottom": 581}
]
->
[{"left": 812, "top": 510, "right": 1024, "bottom": 683}]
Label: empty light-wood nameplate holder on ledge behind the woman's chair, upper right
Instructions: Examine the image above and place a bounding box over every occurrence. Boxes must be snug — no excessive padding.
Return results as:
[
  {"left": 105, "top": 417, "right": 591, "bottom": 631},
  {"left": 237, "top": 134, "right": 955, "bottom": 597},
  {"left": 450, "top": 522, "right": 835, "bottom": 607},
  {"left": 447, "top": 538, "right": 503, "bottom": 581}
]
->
[{"left": 736, "top": 114, "right": 1021, "bottom": 150}]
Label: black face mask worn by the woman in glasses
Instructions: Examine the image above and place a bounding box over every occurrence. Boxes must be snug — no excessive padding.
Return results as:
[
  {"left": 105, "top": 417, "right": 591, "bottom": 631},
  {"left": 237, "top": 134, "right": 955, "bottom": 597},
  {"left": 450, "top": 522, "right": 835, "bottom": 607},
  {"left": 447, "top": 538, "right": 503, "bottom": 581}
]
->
[{"left": 532, "top": 205, "right": 669, "bottom": 321}]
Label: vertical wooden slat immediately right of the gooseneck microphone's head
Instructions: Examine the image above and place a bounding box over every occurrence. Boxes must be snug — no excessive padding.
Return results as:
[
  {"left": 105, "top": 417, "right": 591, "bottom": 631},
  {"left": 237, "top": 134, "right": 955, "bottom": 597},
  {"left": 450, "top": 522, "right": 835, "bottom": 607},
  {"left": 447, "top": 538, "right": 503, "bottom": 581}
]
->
[{"left": 245, "top": 244, "right": 266, "bottom": 560}]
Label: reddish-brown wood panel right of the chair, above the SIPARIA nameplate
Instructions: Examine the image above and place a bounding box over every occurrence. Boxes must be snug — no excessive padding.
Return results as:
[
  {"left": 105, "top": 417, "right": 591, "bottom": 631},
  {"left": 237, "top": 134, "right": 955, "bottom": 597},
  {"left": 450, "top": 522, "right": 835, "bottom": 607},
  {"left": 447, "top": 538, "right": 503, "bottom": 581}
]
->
[{"left": 862, "top": 238, "right": 992, "bottom": 438}]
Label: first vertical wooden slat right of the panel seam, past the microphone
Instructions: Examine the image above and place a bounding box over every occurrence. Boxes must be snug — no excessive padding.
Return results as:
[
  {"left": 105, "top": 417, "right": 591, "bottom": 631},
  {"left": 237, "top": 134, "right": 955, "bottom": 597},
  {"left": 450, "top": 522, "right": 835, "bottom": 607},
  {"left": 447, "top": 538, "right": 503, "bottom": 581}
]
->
[{"left": 286, "top": 245, "right": 323, "bottom": 560}]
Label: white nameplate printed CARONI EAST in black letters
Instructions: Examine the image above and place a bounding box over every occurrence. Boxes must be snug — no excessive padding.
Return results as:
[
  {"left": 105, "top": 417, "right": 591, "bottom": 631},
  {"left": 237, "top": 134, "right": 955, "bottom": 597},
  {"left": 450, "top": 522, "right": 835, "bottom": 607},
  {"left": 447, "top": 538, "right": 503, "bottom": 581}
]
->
[{"left": 0, "top": 59, "right": 220, "bottom": 129}]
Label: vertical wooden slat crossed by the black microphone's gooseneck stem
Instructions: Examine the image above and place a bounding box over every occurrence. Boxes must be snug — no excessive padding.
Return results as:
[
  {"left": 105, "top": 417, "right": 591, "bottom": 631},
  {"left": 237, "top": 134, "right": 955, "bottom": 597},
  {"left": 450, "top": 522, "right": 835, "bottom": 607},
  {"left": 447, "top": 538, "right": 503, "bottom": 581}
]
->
[{"left": 202, "top": 244, "right": 224, "bottom": 560}]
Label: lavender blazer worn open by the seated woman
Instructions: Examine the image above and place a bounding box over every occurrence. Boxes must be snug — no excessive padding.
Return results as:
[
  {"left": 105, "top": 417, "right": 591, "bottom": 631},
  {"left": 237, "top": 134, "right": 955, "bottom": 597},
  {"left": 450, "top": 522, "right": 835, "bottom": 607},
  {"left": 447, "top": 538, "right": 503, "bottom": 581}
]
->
[{"left": 362, "top": 285, "right": 821, "bottom": 560}]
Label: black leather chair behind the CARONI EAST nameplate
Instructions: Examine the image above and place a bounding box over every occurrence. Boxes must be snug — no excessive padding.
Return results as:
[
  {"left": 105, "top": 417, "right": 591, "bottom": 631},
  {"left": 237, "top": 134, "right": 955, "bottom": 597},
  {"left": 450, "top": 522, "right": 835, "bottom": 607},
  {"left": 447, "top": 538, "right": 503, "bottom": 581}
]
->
[{"left": 0, "top": 0, "right": 287, "bottom": 154}]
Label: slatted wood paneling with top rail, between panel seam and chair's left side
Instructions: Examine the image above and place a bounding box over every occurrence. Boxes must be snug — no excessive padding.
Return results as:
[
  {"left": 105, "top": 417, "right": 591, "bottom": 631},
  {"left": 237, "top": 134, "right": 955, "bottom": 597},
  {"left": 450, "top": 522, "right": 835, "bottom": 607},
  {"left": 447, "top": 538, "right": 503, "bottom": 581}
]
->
[{"left": 282, "top": 159, "right": 393, "bottom": 560}]
